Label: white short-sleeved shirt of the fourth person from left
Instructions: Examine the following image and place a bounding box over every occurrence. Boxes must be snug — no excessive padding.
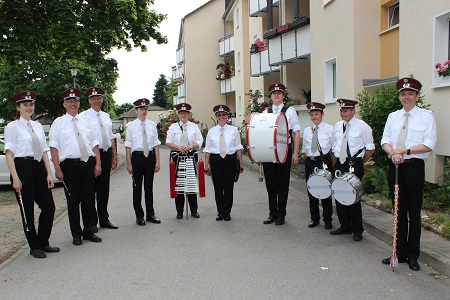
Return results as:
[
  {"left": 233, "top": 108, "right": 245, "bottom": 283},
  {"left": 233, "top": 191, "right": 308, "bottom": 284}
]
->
[{"left": 125, "top": 119, "right": 161, "bottom": 152}]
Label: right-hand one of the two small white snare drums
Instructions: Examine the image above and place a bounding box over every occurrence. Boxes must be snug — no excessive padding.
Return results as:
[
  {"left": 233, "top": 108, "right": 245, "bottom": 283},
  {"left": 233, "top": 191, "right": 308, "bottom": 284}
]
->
[{"left": 331, "top": 170, "right": 364, "bottom": 206}]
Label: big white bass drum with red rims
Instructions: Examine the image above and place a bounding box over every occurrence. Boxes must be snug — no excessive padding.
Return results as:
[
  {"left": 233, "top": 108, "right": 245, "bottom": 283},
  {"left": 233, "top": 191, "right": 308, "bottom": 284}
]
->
[{"left": 246, "top": 113, "right": 289, "bottom": 163}]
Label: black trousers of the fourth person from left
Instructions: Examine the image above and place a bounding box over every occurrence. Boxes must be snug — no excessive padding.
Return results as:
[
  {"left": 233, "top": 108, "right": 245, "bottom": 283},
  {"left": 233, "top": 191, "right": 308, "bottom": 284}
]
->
[{"left": 131, "top": 151, "right": 156, "bottom": 219}]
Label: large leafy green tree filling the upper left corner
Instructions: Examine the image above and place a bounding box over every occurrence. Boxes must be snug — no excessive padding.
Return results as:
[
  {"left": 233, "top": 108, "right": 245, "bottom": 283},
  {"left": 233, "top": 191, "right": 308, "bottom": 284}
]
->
[{"left": 0, "top": 0, "right": 167, "bottom": 121}]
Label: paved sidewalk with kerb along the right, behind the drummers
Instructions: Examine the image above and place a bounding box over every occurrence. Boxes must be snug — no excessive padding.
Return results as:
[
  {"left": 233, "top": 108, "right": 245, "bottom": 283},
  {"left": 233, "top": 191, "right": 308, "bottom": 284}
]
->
[{"left": 243, "top": 155, "right": 450, "bottom": 276}]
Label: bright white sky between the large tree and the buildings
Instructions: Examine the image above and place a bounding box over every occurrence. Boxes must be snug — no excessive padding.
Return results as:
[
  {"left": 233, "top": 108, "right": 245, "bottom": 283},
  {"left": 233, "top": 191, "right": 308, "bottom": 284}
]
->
[{"left": 109, "top": 0, "right": 209, "bottom": 104}]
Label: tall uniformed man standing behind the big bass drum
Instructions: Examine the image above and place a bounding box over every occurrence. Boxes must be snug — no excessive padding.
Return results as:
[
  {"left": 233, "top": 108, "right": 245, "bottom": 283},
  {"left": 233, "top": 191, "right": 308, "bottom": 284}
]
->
[{"left": 263, "top": 83, "right": 300, "bottom": 225}]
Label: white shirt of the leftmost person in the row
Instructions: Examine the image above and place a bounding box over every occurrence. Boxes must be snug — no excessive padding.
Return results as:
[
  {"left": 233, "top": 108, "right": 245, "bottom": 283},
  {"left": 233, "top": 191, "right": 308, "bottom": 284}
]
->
[{"left": 5, "top": 117, "right": 50, "bottom": 157}]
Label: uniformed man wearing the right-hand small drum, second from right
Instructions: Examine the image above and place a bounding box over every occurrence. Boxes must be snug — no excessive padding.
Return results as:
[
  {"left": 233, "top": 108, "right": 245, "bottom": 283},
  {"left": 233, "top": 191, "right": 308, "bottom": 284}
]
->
[{"left": 330, "top": 99, "right": 375, "bottom": 242}]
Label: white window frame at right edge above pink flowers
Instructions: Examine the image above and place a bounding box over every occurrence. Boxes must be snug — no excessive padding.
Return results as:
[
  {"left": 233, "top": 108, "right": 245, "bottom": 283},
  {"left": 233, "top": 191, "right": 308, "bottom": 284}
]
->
[{"left": 430, "top": 9, "right": 450, "bottom": 88}]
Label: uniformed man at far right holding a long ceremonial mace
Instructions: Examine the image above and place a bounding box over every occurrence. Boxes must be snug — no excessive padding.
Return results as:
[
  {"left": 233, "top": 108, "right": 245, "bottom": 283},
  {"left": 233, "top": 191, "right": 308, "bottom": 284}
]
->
[{"left": 381, "top": 78, "right": 436, "bottom": 271}]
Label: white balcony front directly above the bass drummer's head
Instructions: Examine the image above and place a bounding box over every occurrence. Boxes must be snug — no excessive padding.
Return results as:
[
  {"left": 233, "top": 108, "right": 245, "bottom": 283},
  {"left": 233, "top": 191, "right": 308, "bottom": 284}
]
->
[{"left": 268, "top": 24, "right": 311, "bottom": 66}]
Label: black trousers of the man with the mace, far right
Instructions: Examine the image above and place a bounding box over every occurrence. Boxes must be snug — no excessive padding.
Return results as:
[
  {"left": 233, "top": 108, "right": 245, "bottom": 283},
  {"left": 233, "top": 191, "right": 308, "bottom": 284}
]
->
[{"left": 388, "top": 159, "right": 425, "bottom": 259}]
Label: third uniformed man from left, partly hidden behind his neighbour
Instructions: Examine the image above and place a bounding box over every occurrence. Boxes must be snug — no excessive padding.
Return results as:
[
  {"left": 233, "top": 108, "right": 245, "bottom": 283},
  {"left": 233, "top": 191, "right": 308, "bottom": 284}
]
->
[{"left": 80, "top": 87, "right": 119, "bottom": 232}]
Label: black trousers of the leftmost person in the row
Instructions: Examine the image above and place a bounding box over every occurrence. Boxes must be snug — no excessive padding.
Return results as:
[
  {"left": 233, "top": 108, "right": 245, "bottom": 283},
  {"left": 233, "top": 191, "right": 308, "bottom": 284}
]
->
[{"left": 11, "top": 158, "right": 55, "bottom": 250}]
